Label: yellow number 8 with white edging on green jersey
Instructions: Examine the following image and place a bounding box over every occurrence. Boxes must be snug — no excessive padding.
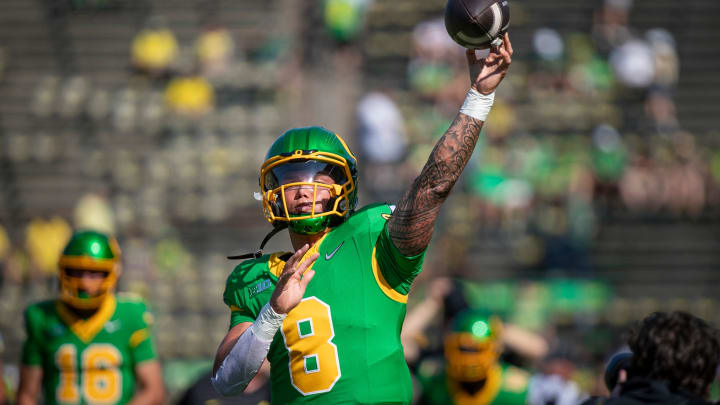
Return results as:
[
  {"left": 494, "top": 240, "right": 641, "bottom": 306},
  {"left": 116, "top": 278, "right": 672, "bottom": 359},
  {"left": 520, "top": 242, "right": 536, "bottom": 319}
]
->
[{"left": 281, "top": 297, "right": 340, "bottom": 395}]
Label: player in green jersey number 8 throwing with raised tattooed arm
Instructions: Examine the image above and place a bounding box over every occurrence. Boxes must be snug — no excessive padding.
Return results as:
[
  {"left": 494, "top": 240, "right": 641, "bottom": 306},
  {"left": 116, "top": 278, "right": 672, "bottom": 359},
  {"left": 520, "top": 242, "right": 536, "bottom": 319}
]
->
[{"left": 212, "top": 35, "right": 512, "bottom": 404}]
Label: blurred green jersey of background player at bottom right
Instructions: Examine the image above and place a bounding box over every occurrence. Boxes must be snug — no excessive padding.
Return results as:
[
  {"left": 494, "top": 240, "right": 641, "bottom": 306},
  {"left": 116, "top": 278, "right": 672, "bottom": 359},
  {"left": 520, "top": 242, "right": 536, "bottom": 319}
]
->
[{"left": 420, "top": 364, "right": 530, "bottom": 405}]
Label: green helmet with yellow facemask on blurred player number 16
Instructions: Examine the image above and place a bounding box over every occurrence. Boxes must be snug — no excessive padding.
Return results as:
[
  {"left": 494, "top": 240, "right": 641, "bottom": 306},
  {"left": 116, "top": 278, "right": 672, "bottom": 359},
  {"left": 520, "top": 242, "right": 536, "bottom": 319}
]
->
[{"left": 58, "top": 231, "right": 120, "bottom": 309}]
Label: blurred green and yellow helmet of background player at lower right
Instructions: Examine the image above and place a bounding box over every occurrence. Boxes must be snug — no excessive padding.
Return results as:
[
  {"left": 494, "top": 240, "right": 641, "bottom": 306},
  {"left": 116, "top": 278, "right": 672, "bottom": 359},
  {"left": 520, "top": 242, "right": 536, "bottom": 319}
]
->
[{"left": 445, "top": 309, "right": 502, "bottom": 382}]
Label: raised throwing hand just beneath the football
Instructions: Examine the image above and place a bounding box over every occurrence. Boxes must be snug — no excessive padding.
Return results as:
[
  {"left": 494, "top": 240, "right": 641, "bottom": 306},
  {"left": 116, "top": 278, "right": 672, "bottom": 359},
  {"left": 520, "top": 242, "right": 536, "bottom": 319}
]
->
[{"left": 465, "top": 33, "right": 513, "bottom": 94}]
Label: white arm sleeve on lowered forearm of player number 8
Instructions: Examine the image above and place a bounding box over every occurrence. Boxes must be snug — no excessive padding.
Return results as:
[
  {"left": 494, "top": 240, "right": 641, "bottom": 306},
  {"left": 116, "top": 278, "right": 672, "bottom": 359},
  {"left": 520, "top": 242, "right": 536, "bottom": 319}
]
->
[{"left": 210, "top": 303, "right": 286, "bottom": 396}]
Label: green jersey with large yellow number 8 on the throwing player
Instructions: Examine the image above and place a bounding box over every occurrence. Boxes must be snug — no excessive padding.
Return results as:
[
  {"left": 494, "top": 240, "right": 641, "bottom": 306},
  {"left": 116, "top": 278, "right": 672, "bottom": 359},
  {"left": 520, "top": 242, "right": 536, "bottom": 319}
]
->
[{"left": 224, "top": 204, "right": 424, "bottom": 404}]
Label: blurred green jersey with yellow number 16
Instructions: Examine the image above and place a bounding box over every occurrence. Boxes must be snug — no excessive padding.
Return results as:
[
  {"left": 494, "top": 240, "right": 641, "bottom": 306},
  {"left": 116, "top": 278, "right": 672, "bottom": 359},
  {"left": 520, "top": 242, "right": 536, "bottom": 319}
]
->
[{"left": 22, "top": 295, "right": 156, "bottom": 405}]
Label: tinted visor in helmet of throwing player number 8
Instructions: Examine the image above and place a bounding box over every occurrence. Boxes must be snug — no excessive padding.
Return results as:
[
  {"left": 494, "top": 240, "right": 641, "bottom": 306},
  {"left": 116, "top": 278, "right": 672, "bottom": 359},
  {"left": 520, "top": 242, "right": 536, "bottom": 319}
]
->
[{"left": 265, "top": 160, "right": 348, "bottom": 190}]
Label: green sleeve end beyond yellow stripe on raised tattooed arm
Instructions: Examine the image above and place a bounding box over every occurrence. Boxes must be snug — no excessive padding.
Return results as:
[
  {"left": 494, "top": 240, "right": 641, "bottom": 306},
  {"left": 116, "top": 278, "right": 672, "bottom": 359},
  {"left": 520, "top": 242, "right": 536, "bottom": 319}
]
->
[{"left": 375, "top": 215, "right": 425, "bottom": 295}]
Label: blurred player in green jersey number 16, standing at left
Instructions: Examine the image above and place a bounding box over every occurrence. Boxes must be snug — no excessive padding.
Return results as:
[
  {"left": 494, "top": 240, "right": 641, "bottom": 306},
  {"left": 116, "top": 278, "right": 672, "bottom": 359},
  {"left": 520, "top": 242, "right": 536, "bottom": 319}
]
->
[{"left": 18, "top": 231, "right": 164, "bottom": 405}]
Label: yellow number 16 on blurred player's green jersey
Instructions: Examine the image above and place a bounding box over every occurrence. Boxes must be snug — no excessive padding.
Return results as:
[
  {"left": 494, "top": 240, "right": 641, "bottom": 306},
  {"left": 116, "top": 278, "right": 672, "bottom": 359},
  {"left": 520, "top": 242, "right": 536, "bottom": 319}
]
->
[{"left": 55, "top": 343, "right": 122, "bottom": 404}]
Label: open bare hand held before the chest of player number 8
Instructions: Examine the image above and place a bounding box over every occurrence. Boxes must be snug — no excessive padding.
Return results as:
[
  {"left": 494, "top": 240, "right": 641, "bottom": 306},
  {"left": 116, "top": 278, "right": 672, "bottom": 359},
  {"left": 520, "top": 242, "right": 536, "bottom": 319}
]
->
[{"left": 270, "top": 244, "right": 319, "bottom": 314}]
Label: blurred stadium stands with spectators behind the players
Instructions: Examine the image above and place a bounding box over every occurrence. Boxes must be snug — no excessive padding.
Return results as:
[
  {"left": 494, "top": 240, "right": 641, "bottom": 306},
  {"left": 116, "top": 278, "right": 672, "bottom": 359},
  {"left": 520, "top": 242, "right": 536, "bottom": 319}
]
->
[{"left": 0, "top": 0, "right": 720, "bottom": 398}]
